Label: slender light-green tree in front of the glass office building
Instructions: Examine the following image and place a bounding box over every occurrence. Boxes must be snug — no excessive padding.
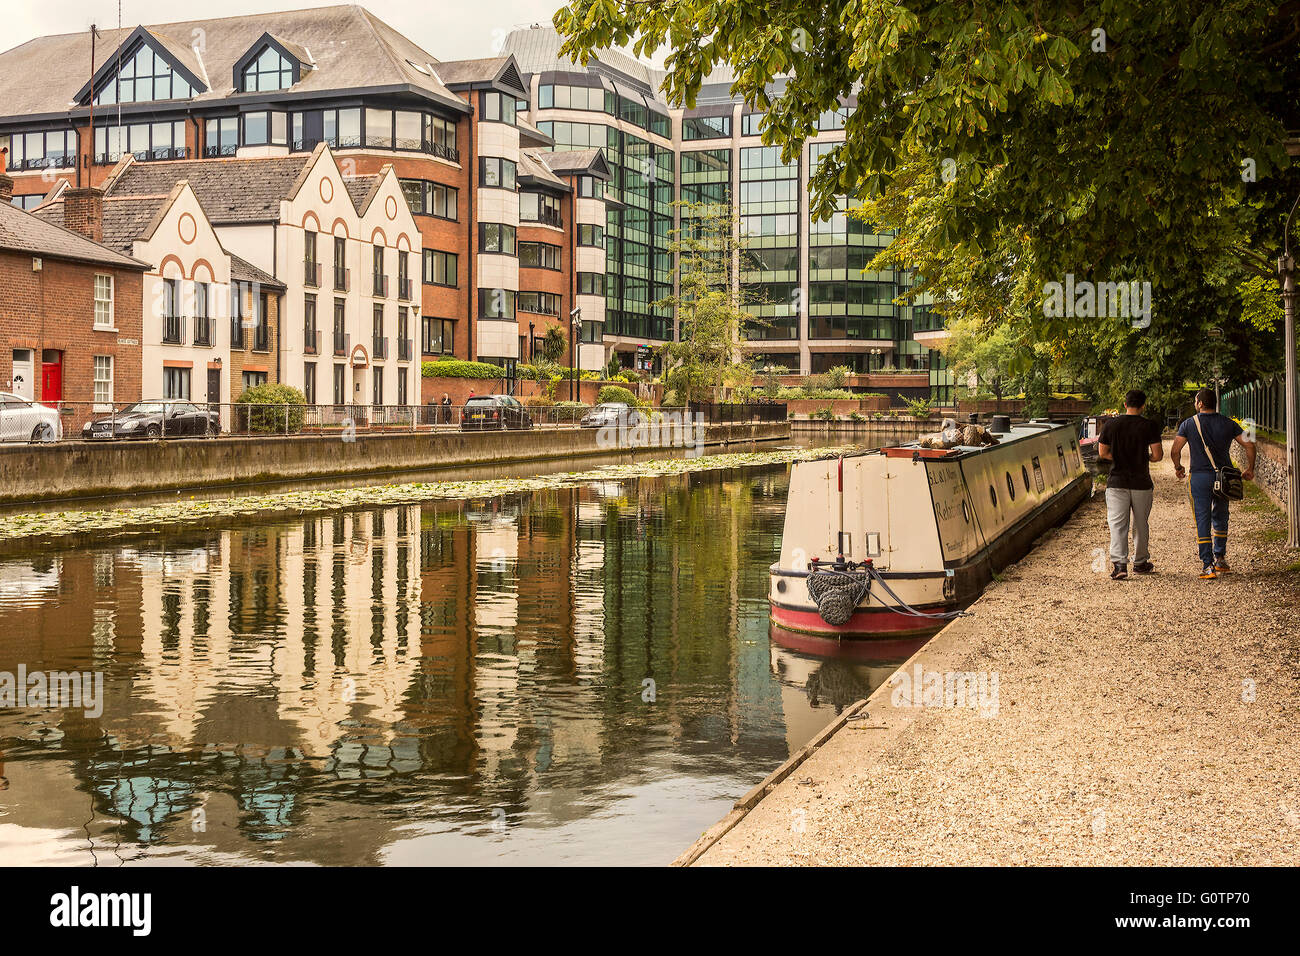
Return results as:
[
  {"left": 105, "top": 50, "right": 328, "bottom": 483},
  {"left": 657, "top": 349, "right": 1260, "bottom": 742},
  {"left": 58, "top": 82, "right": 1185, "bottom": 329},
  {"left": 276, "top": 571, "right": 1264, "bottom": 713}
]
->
[{"left": 655, "top": 202, "right": 755, "bottom": 405}]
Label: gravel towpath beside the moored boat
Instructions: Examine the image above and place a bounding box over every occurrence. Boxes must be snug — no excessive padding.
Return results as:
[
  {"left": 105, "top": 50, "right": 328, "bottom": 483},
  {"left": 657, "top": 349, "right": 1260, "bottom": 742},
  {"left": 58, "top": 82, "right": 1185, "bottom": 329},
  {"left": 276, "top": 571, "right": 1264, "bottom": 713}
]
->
[{"left": 696, "top": 447, "right": 1300, "bottom": 866}]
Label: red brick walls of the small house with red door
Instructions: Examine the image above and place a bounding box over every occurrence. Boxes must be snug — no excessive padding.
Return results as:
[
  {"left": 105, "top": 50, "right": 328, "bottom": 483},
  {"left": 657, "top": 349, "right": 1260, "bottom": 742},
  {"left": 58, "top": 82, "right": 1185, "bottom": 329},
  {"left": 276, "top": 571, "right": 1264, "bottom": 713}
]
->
[{"left": 0, "top": 251, "right": 143, "bottom": 431}]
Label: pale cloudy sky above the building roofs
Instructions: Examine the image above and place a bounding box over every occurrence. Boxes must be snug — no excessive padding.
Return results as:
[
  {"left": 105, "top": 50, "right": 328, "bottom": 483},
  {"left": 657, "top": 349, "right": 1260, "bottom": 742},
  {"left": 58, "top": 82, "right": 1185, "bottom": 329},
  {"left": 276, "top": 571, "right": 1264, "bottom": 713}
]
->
[{"left": 0, "top": 0, "right": 658, "bottom": 60}]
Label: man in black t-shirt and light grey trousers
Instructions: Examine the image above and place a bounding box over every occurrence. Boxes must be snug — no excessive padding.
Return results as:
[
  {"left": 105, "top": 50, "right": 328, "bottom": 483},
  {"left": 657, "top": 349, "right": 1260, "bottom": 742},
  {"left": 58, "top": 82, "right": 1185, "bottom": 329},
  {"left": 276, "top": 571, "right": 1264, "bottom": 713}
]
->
[{"left": 1097, "top": 389, "right": 1165, "bottom": 581}]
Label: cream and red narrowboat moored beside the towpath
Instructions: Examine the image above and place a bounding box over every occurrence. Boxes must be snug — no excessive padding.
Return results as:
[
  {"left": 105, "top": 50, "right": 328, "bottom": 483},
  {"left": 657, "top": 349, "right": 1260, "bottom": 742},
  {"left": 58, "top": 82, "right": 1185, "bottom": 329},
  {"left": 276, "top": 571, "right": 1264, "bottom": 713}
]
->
[{"left": 768, "top": 421, "right": 1092, "bottom": 637}]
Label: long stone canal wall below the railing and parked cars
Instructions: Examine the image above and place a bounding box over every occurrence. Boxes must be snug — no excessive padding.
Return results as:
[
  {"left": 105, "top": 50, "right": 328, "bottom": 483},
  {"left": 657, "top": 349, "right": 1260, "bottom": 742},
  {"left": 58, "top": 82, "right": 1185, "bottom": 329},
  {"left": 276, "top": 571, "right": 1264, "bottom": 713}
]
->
[{"left": 0, "top": 421, "right": 790, "bottom": 503}]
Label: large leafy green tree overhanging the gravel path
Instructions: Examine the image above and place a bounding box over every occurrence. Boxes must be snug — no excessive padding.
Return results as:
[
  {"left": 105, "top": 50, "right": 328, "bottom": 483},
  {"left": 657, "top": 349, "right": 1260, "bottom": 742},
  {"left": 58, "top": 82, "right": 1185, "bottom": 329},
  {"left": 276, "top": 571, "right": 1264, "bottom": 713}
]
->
[{"left": 555, "top": 0, "right": 1300, "bottom": 401}]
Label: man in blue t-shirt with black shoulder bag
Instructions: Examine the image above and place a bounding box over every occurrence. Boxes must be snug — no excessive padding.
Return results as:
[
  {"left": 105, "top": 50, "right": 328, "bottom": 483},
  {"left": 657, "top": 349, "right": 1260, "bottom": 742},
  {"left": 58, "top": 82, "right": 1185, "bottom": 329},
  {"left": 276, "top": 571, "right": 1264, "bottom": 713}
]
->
[{"left": 1169, "top": 389, "right": 1255, "bottom": 580}]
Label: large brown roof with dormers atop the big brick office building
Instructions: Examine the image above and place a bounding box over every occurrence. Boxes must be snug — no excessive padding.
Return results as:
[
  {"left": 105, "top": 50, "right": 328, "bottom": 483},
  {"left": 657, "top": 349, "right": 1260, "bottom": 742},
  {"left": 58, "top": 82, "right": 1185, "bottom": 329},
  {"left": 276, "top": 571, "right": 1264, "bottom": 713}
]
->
[{"left": 0, "top": 5, "right": 468, "bottom": 117}]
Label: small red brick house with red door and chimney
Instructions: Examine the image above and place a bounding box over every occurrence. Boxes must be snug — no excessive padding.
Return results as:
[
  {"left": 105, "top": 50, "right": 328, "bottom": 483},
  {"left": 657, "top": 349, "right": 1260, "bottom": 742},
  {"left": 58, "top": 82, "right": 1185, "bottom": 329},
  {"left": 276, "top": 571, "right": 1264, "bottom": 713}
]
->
[{"left": 0, "top": 174, "right": 150, "bottom": 432}]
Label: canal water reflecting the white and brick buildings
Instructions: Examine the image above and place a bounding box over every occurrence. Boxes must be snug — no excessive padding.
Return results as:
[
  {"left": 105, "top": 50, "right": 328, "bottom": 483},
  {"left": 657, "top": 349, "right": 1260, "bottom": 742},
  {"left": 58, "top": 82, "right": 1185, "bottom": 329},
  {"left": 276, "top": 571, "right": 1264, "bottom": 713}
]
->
[{"left": 0, "top": 457, "right": 925, "bottom": 866}]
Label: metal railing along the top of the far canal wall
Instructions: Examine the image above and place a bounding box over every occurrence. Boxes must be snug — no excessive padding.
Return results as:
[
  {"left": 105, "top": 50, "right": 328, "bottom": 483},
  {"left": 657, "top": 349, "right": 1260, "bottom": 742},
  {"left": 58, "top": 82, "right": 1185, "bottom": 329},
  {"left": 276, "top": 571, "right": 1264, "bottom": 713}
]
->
[{"left": 0, "top": 401, "right": 696, "bottom": 441}]
